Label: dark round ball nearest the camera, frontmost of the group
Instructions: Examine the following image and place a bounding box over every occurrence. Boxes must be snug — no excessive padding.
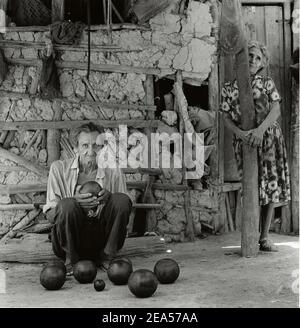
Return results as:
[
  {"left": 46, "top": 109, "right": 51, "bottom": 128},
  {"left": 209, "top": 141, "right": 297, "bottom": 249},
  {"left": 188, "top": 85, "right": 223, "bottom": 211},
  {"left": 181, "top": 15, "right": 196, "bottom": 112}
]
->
[{"left": 128, "top": 269, "right": 158, "bottom": 298}]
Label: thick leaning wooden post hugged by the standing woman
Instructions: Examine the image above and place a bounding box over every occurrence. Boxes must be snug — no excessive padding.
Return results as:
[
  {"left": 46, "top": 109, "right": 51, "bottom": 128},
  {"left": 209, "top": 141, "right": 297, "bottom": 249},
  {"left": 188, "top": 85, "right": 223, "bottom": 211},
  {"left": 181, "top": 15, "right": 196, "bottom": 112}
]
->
[{"left": 220, "top": 0, "right": 259, "bottom": 257}]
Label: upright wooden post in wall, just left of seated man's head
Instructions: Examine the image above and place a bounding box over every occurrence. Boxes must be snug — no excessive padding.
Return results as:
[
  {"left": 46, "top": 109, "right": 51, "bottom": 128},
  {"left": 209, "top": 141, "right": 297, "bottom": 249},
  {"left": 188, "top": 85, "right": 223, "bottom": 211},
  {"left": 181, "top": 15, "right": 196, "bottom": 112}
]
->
[{"left": 47, "top": 101, "right": 63, "bottom": 165}]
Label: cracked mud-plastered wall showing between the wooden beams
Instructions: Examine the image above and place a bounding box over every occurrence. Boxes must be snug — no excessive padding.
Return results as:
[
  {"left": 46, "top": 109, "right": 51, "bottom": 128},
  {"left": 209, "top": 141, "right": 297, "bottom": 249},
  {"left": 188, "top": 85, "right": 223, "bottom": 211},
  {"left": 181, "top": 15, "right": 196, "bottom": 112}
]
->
[{"left": 0, "top": 1, "right": 217, "bottom": 241}]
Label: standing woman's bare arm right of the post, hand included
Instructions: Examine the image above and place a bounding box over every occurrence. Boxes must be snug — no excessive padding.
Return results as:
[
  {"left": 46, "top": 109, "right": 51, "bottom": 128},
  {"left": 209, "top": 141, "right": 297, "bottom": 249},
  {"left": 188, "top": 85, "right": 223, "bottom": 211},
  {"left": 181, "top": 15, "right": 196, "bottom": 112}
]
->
[{"left": 249, "top": 101, "right": 280, "bottom": 147}]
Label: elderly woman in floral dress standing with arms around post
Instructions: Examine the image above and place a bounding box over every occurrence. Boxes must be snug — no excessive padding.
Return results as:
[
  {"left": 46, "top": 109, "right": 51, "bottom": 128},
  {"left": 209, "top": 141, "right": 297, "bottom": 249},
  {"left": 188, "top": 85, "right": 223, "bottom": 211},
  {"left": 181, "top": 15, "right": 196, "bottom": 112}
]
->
[{"left": 221, "top": 42, "right": 290, "bottom": 252}]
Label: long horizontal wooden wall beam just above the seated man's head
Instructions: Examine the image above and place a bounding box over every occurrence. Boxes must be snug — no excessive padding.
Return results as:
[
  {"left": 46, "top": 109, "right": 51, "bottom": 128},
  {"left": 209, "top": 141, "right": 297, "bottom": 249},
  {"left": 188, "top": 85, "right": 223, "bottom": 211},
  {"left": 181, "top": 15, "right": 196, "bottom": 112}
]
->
[{"left": 0, "top": 120, "right": 161, "bottom": 131}]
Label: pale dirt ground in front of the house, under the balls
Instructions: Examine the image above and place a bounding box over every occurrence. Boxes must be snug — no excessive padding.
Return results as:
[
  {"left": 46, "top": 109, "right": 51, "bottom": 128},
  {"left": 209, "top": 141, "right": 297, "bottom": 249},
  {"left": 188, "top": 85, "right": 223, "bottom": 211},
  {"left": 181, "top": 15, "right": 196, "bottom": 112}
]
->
[{"left": 0, "top": 232, "right": 299, "bottom": 308}]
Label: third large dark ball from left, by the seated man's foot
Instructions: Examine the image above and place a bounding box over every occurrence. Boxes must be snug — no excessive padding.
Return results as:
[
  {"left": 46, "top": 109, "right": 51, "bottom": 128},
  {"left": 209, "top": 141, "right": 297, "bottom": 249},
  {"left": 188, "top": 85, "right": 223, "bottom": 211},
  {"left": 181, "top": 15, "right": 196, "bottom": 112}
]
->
[{"left": 107, "top": 259, "right": 132, "bottom": 285}]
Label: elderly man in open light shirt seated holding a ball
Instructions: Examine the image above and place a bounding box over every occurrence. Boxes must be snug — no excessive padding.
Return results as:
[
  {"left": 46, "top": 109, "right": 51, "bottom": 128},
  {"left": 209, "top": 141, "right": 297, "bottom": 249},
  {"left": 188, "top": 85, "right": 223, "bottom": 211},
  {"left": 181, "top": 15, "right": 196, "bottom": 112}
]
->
[{"left": 44, "top": 123, "right": 132, "bottom": 273}]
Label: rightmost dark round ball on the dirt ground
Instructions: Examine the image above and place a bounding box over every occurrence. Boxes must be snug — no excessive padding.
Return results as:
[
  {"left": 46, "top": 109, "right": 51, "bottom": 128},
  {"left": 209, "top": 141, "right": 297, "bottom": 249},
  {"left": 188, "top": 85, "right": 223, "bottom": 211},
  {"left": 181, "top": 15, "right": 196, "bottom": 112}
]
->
[{"left": 154, "top": 259, "right": 180, "bottom": 284}]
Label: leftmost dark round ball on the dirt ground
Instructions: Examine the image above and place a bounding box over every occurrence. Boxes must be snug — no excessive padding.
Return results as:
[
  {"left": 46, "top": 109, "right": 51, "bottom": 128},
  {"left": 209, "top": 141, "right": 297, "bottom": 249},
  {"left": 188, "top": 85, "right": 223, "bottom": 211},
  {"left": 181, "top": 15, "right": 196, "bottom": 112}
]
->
[{"left": 40, "top": 265, "right": 66, "bottom": 290}]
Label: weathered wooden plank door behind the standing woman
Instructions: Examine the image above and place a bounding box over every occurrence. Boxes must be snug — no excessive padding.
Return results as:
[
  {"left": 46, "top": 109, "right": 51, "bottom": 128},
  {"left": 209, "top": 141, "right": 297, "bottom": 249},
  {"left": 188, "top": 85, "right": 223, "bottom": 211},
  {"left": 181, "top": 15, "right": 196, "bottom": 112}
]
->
[{"left": 243, "top": 1, "right": 291, "bottom": 158}]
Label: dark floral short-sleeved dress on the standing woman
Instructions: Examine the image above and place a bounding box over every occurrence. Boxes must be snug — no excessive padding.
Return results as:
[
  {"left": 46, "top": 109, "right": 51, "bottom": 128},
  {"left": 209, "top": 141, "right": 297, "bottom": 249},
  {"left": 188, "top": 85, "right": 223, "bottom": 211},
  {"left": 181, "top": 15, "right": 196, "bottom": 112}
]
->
[{"left": 221, "top": 75, "right": 290, "bottom": 205}]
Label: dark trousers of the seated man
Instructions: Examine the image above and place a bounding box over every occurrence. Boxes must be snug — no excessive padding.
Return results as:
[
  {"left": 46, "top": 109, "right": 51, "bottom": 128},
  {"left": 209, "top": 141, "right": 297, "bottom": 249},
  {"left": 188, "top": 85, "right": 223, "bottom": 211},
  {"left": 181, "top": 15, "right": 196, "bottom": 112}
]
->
[{"left": 51, "top": 193, "right": 132, "bottom": 264}]
